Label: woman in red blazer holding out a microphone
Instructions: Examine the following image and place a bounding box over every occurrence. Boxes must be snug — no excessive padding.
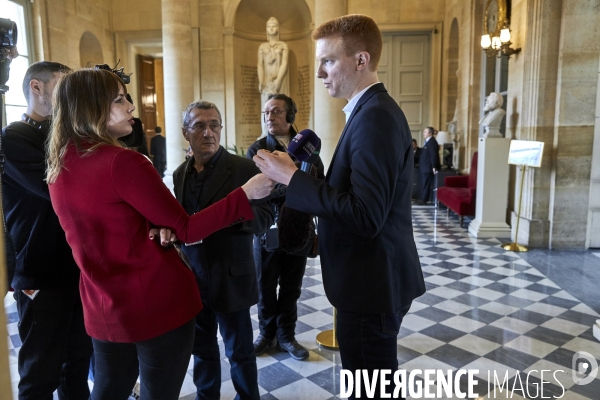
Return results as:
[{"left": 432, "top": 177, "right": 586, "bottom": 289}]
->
[{"left": 47, "top": 69, "right": 271, "bottom": 400}]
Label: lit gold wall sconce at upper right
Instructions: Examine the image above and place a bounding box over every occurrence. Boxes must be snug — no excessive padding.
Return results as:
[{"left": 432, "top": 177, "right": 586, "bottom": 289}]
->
[{"left": 481, "top": 0, "right": 521, "bottom": 58}]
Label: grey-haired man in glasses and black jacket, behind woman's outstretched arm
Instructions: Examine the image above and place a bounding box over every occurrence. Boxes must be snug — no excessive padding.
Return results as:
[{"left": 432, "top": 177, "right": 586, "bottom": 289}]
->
[{"left": 173, "top": 101, "right": 273, "bottom": 399}]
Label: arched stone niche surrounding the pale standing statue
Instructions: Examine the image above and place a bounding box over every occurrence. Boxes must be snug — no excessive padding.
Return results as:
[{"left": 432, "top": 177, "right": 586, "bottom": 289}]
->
[{"left": 233, "top": 0, "right": 314, "bottom": 150}]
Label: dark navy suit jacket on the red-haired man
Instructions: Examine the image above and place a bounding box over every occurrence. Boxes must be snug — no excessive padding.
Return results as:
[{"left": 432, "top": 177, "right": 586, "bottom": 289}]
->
[{"left": 287, "top": 83, "right": 425, "bottom": 313}]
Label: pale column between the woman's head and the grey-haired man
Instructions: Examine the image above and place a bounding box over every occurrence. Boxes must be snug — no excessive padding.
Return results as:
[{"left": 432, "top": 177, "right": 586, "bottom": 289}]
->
[{"left": 162, "top": 0, "right": 194, "bottom": 175}]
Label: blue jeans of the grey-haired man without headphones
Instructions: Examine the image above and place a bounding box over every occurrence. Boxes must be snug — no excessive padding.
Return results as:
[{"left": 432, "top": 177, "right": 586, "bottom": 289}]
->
[{"left": 192, "top": 303, "right": 260, "bottom": 400}]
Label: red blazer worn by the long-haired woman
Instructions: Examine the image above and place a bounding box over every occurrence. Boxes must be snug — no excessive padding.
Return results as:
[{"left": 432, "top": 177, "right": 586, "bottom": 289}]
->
[{"left": 49, "top": 145, "right": 254, "bottom": 342}]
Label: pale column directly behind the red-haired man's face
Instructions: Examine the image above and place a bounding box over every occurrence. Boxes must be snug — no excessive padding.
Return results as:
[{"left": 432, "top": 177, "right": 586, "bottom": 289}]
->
[{"left": 314, "top": 0, "right": 347, "bottom": 168}]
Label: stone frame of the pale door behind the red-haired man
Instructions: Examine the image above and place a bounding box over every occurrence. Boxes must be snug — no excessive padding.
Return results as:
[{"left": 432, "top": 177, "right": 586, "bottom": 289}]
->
[{"left": 377, "top": 21, "right": 444, "bottom": 130}]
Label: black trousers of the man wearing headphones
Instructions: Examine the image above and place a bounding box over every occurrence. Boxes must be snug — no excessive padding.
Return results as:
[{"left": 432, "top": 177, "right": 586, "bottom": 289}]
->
[{"left": 254, "top": 240, "right": 306, "bottom": 342}]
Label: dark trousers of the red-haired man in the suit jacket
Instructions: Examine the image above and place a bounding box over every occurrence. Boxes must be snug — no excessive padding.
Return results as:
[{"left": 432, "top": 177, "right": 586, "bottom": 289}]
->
[{"left": 337, "top": 304, "right": 410, "bottom": 399}]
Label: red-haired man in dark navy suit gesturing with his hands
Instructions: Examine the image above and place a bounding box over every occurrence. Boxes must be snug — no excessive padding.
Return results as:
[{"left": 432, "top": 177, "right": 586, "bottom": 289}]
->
[{"left": 254, "top": 14, "right": 425, "bottom": 398}]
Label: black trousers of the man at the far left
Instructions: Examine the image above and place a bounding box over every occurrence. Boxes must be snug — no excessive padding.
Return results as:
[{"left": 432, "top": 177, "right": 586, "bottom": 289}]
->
[{"left": 14, "top": 283, "right": 92, "bottom": 400}]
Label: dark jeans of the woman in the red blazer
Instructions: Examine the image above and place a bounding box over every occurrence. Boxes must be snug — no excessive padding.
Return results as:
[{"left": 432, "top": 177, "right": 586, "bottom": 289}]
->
[{"left": 86, "top": 320, "right": 194, "bottom": 400}]
